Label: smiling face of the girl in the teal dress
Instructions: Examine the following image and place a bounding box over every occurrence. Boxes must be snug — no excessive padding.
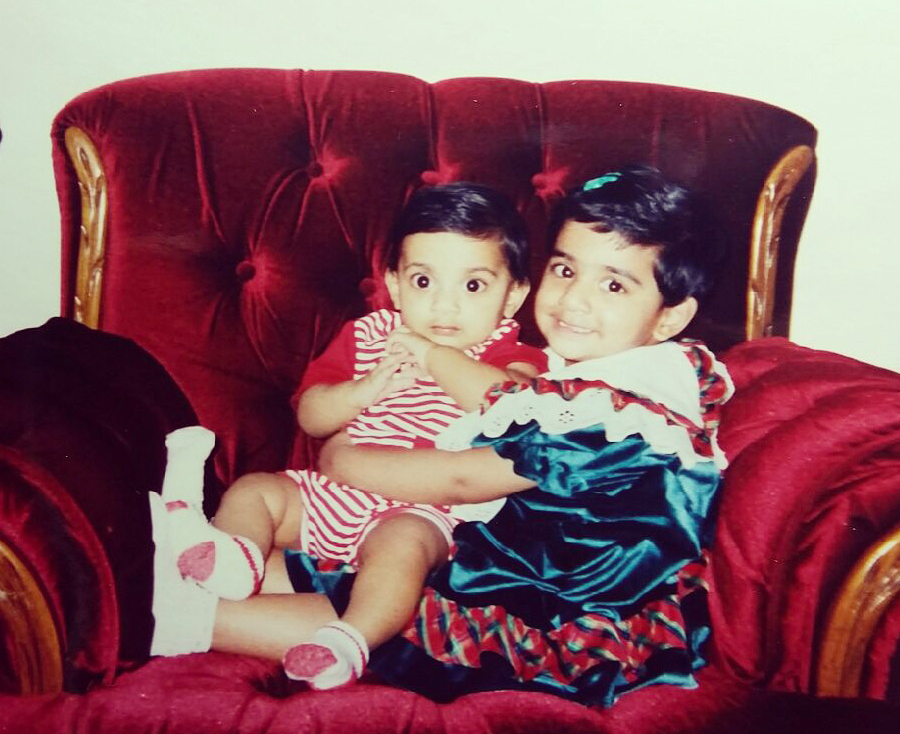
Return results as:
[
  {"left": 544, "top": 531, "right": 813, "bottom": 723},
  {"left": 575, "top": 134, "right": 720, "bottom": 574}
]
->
[{"left": 535, "top": 221, "right": 696, "bottom": 362}]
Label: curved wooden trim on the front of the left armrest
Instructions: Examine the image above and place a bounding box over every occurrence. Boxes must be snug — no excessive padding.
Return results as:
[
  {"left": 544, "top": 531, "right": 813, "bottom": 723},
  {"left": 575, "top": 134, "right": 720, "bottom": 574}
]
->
[{"left": 0, "top": 542, "right": 63, "bottom": 694}]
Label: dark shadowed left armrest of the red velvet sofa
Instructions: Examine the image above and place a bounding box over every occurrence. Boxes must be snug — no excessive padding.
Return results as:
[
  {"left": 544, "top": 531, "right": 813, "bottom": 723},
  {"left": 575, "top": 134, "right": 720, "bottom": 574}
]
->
[{"left": 0, "top": 319, "right": 213, "bottom": 692}]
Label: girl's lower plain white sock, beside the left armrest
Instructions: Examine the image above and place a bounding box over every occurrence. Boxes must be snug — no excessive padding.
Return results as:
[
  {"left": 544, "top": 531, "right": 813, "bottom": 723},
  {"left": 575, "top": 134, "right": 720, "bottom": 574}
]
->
[{"left": 149, "top": 492, "right": 219, "bottom": 656}]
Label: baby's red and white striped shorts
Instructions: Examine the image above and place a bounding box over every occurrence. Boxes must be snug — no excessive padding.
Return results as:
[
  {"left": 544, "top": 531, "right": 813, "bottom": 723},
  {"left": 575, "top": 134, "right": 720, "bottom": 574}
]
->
[{"left": 284, "top": 469, "right": 459, "bottom": 565}]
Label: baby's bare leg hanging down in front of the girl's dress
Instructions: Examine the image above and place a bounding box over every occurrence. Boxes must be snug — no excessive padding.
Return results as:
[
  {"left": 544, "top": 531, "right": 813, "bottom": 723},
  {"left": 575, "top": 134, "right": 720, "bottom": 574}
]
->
[{"left": 341, "top": 513, "right": 448, "bottom": 648}]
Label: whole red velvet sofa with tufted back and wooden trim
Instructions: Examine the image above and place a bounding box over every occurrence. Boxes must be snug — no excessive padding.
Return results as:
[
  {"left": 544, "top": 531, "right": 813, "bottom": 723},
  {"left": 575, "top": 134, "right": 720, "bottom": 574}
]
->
[{"left": 0, "top": 69, "right": 900, "bottom": 734}]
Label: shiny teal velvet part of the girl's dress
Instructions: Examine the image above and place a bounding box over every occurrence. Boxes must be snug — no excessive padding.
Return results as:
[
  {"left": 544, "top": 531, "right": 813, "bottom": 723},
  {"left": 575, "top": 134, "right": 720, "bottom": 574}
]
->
[{"left": 440, "top": 434, "right": 719, "bottom": 627}]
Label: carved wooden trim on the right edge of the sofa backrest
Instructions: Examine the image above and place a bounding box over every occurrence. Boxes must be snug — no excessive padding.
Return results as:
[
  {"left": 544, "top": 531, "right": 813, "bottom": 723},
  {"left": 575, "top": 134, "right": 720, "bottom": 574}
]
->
[{"left": 746, "top": 145, "right": 814, "bottom": 339}]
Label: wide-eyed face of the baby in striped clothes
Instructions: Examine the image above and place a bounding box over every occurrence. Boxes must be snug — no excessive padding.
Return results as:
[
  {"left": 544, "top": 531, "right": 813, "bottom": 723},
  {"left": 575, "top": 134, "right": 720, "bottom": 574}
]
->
[{"left": 385, "top": 232, "right": 528, "bottom": 349}]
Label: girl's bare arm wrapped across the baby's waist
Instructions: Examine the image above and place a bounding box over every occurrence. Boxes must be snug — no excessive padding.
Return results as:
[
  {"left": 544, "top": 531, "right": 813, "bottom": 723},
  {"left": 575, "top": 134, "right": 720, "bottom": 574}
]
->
[{"left": 319, "top": 437, "right": 534, "bottom": 505}]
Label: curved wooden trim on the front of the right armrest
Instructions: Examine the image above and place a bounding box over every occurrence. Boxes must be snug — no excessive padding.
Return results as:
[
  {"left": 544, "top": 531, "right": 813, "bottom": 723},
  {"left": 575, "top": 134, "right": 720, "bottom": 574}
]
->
[{"left": 816, "top": 527, "right": 900, "bottom": 698}]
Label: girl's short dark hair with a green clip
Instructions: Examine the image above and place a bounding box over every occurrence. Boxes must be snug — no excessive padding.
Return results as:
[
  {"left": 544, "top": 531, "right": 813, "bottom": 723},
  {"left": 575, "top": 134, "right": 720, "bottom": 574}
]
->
[{"left": 550, "top": 165, "right": 722, "bottom": 306}]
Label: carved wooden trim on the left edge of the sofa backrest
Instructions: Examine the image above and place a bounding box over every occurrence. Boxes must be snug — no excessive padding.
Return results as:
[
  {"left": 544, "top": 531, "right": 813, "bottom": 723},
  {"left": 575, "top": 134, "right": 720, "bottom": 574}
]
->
[{"left": 66, "top": 127, "right": 107, "bottom": 329}]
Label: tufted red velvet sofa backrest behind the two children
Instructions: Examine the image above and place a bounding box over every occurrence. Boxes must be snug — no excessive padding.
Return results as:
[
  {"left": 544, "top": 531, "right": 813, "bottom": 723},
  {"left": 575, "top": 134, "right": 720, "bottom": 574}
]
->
[{"left": 52, "top": 69, "right": 816, "bottom": 494}]
